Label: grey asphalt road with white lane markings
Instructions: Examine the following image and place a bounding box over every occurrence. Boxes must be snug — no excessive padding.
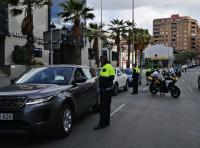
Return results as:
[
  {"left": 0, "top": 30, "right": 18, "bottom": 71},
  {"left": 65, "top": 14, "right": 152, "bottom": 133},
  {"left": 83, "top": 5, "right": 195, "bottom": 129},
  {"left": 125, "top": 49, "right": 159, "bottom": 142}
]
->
[{"left": 0, "top": 68, "right": 200, "bottom": 148}]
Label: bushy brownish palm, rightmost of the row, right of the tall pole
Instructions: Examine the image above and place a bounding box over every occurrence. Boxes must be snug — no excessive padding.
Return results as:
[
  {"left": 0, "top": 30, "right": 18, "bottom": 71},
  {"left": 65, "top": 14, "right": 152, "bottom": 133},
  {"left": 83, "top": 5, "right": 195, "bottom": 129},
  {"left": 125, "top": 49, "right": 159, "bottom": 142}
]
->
[{"left": 134, "top": 28, "right": 150, "bottom": 65}]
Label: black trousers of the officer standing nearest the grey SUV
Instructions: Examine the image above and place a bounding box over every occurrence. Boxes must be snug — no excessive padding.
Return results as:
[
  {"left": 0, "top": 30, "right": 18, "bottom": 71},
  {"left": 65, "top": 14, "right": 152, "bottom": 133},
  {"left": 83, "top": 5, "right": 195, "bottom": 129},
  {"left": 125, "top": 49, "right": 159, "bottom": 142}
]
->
[{"left": 99, "top": 91, "right": 112, "bottom": 126}]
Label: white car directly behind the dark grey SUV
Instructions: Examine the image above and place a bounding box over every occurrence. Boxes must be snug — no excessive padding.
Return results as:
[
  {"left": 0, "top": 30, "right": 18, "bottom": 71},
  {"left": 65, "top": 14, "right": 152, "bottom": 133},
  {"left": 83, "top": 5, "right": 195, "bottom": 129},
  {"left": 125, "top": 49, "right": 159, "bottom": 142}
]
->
[{"left": 96, "top": 67, "right": 129, "bottom": 96}]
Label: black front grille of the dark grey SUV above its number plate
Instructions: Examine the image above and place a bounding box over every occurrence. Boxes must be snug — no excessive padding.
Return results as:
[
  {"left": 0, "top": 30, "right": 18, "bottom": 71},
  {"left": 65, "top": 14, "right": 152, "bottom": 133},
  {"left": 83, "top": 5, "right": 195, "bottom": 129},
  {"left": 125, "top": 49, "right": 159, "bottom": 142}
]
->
[{"left": 0, "top": 96, "right": 27, "bottom": 108}]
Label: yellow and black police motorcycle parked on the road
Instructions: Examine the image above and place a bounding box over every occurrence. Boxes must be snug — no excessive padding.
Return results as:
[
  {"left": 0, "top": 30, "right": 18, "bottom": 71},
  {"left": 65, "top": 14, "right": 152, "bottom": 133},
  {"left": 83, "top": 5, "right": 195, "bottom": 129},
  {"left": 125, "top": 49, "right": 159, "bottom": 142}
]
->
[{"left": 147, "top": 71, "right": 181, "bottom": 99}]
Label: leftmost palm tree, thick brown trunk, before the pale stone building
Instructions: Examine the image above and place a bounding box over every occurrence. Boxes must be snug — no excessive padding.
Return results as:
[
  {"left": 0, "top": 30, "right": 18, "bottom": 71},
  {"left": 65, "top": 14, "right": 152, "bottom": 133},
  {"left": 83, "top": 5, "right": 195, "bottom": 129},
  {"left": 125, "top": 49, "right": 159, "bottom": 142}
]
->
[{"left": 0, "top": 0, "right": 50, "bottom": 65}]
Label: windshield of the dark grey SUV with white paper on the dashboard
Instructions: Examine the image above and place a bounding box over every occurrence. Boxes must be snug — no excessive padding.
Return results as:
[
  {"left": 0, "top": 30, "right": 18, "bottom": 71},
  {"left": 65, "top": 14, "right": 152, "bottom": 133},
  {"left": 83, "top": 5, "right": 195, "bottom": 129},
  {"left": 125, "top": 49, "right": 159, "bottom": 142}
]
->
[{"left": 15, "top": 67, "right": 73, "bottom": 85}]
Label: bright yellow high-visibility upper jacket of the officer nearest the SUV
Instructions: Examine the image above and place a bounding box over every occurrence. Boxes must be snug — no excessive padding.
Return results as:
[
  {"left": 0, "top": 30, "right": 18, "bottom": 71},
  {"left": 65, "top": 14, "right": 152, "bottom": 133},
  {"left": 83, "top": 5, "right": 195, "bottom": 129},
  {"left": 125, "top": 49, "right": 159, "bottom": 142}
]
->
[{"left": 100, "top": 63, "right": 115, "bottom": 77}]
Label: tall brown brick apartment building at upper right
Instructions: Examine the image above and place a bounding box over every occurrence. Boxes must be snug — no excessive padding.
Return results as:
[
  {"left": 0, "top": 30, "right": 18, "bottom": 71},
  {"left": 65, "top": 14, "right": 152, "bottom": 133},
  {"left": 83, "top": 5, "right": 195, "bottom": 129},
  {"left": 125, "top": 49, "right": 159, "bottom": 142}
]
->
[{"left": 153, "top": 14, "right": 200, "bottom": 53}]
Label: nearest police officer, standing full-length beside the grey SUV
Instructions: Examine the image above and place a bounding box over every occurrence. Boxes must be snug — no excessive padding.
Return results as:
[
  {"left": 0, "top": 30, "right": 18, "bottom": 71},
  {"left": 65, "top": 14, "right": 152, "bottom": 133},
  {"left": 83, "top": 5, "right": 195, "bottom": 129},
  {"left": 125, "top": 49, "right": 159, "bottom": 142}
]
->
[{"left": 94, "top": 55, "right": 115, "bottom": 130}]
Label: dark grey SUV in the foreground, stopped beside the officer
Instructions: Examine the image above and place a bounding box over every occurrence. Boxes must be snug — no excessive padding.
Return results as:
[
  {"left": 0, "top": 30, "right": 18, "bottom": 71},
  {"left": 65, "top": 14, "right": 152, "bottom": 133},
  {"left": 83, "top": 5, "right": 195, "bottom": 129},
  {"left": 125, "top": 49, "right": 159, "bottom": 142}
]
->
[{"left": 0, "top": 65, "right": 98, "bottom": 137}]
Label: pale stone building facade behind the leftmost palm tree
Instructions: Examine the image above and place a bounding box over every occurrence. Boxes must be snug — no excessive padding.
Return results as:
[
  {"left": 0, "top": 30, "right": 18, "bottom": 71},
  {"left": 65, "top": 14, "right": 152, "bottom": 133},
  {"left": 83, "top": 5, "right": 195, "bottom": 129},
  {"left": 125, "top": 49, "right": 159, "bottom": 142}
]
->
[{"left": 0, "top": 5, "right": 49, "bottom": 65}]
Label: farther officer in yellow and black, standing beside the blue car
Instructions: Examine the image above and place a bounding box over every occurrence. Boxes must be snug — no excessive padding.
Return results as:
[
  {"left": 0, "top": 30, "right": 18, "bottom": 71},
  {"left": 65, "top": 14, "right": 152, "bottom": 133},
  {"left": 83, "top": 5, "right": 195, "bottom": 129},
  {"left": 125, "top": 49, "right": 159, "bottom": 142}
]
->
[{"left": 131, "top": 64, "right": 140, "bottom": 94}]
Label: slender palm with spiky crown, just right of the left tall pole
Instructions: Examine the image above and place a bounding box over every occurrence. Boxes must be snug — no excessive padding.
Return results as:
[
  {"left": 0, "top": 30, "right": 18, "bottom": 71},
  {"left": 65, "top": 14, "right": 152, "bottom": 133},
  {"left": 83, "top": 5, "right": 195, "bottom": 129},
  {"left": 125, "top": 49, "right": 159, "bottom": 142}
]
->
[{"left": 108, "top": 19, "right": 124, "bottom": 66}]
